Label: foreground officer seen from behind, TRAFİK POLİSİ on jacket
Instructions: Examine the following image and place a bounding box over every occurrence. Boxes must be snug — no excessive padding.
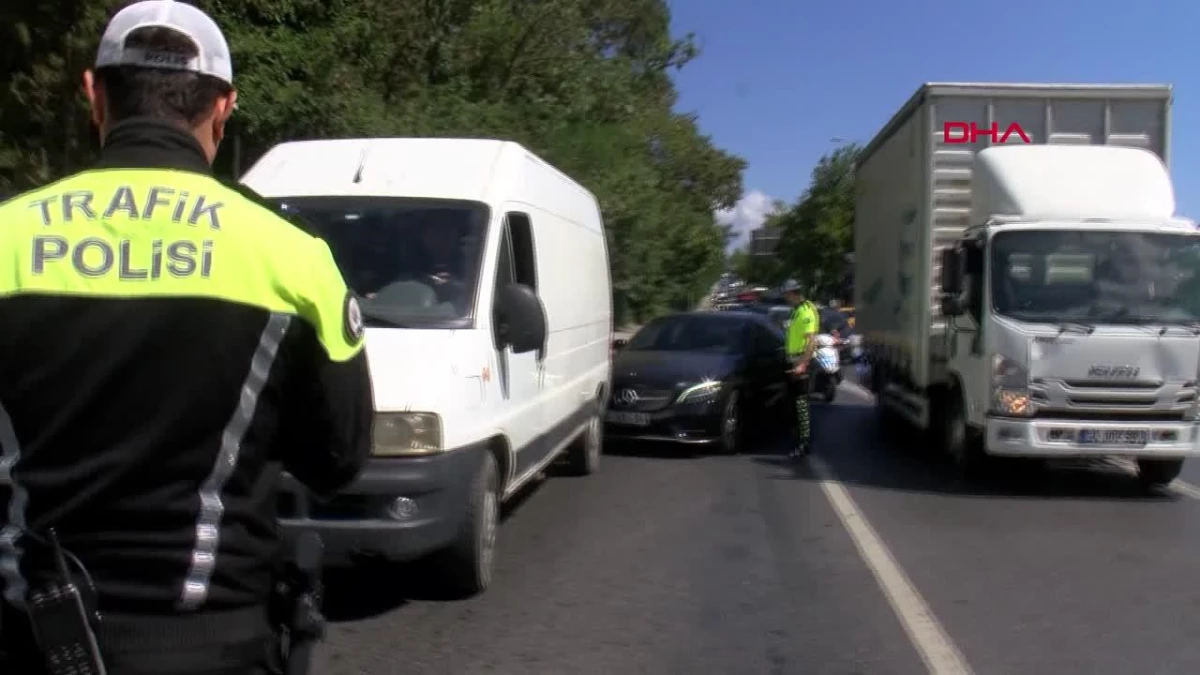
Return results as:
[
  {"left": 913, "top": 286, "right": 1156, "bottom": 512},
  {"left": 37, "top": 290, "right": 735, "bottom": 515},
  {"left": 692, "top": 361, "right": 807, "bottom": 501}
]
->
[{"left": 0, "top": 0, "right": 372, "bottom": 675}]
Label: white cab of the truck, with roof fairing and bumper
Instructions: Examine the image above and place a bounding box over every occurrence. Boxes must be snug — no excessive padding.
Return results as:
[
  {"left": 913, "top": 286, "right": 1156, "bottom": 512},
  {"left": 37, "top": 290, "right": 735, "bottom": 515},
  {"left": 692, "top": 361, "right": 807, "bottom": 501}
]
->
[{"left": 930, "top": 145, "right": 1200, "bottom": 486}]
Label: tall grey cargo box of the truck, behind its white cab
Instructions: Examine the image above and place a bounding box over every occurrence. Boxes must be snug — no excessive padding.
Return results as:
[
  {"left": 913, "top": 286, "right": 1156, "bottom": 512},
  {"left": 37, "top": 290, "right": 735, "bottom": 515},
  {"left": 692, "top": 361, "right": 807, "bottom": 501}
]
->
[{"left": 854, "top": 84, "right": 1171, "bottom": 388}]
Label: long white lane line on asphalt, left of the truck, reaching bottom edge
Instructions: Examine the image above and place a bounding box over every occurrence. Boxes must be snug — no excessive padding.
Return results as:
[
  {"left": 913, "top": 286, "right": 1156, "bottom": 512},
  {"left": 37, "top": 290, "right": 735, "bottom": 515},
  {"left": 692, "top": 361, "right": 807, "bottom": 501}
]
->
[{"left": 809, "top": 456, "right": 972, "bottom": 675}]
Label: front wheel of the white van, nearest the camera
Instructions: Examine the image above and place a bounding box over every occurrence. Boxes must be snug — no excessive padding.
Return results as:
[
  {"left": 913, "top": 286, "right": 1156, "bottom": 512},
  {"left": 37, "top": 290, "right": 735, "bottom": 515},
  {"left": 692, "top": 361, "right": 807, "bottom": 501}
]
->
[{"left": 430, "top": 453, "right": 500, "bottom": 598}]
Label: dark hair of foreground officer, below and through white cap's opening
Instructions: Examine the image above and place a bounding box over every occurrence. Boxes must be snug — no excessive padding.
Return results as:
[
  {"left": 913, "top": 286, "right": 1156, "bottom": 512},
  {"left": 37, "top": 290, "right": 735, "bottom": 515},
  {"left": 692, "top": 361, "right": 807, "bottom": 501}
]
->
[{"left": 96, "top": 26, "right": 230, "bottom": 126}]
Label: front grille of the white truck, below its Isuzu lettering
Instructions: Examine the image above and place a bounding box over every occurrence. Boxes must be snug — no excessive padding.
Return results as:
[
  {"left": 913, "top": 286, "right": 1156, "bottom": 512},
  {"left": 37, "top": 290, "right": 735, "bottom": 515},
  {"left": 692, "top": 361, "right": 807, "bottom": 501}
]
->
[{"left": 1030, "top": 378, "right": 1196, "bottom": 419}]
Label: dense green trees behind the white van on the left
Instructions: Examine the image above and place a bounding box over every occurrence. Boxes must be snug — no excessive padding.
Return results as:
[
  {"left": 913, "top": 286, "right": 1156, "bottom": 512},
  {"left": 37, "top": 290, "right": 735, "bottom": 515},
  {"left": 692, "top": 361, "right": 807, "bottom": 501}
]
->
[{"left": 0, "top": 0, "right": 744, "bottom": 319}]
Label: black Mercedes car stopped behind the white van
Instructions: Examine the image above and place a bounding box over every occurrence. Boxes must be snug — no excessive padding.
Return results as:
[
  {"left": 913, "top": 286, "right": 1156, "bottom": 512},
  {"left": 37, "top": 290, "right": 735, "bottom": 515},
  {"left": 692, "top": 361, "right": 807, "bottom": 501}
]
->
[{"left": 605, "top": 311, "right": 788, "bottom": 453}]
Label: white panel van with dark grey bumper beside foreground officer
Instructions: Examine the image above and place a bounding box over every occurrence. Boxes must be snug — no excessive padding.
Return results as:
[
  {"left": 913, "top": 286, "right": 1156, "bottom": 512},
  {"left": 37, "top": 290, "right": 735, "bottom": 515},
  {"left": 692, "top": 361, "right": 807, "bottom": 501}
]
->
[{"left": 242, "top": 138, "right": 612, "bottom": 596}]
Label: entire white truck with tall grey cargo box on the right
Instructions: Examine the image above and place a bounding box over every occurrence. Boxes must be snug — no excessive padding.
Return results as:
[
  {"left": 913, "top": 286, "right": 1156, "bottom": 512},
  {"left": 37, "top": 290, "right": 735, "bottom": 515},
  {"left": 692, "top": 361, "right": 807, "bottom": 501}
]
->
[{"left": 854, "top": 84, "right": 1200, "bottom": 486}]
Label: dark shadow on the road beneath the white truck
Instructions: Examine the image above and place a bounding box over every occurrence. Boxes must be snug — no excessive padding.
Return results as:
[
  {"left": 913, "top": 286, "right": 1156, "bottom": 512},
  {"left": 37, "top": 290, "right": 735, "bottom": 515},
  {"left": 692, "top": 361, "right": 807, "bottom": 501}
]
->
[{"left": 755, "top": 396, "right": 1181, "bottom": 502}]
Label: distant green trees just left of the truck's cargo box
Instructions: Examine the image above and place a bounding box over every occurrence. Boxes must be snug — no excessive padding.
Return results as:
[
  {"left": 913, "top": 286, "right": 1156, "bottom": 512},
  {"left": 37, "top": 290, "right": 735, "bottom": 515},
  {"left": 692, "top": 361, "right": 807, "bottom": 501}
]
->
[{"left": 732, "top": 144, "right": 862, "bottom": 300}]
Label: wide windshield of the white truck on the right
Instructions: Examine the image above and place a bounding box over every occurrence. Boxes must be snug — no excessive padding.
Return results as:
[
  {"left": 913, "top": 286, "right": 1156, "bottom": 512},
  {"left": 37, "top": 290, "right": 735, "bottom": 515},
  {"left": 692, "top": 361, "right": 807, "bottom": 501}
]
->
[{"left": 991, "top": 231, "right": 1200, "bottom": 324}]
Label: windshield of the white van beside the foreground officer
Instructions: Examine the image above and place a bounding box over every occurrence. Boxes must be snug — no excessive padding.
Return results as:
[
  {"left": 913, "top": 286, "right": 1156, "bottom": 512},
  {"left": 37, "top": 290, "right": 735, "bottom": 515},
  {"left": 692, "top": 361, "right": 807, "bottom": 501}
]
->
[{"left": 276, "top": 197, "right": 490, "bottom": 328}]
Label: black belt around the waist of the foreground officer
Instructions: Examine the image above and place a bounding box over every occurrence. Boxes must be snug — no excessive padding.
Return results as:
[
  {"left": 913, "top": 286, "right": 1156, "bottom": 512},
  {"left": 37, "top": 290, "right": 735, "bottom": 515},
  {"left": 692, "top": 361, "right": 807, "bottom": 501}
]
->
[{"left": 96, "top": 607, "right": 274, "bottom": 652}]
